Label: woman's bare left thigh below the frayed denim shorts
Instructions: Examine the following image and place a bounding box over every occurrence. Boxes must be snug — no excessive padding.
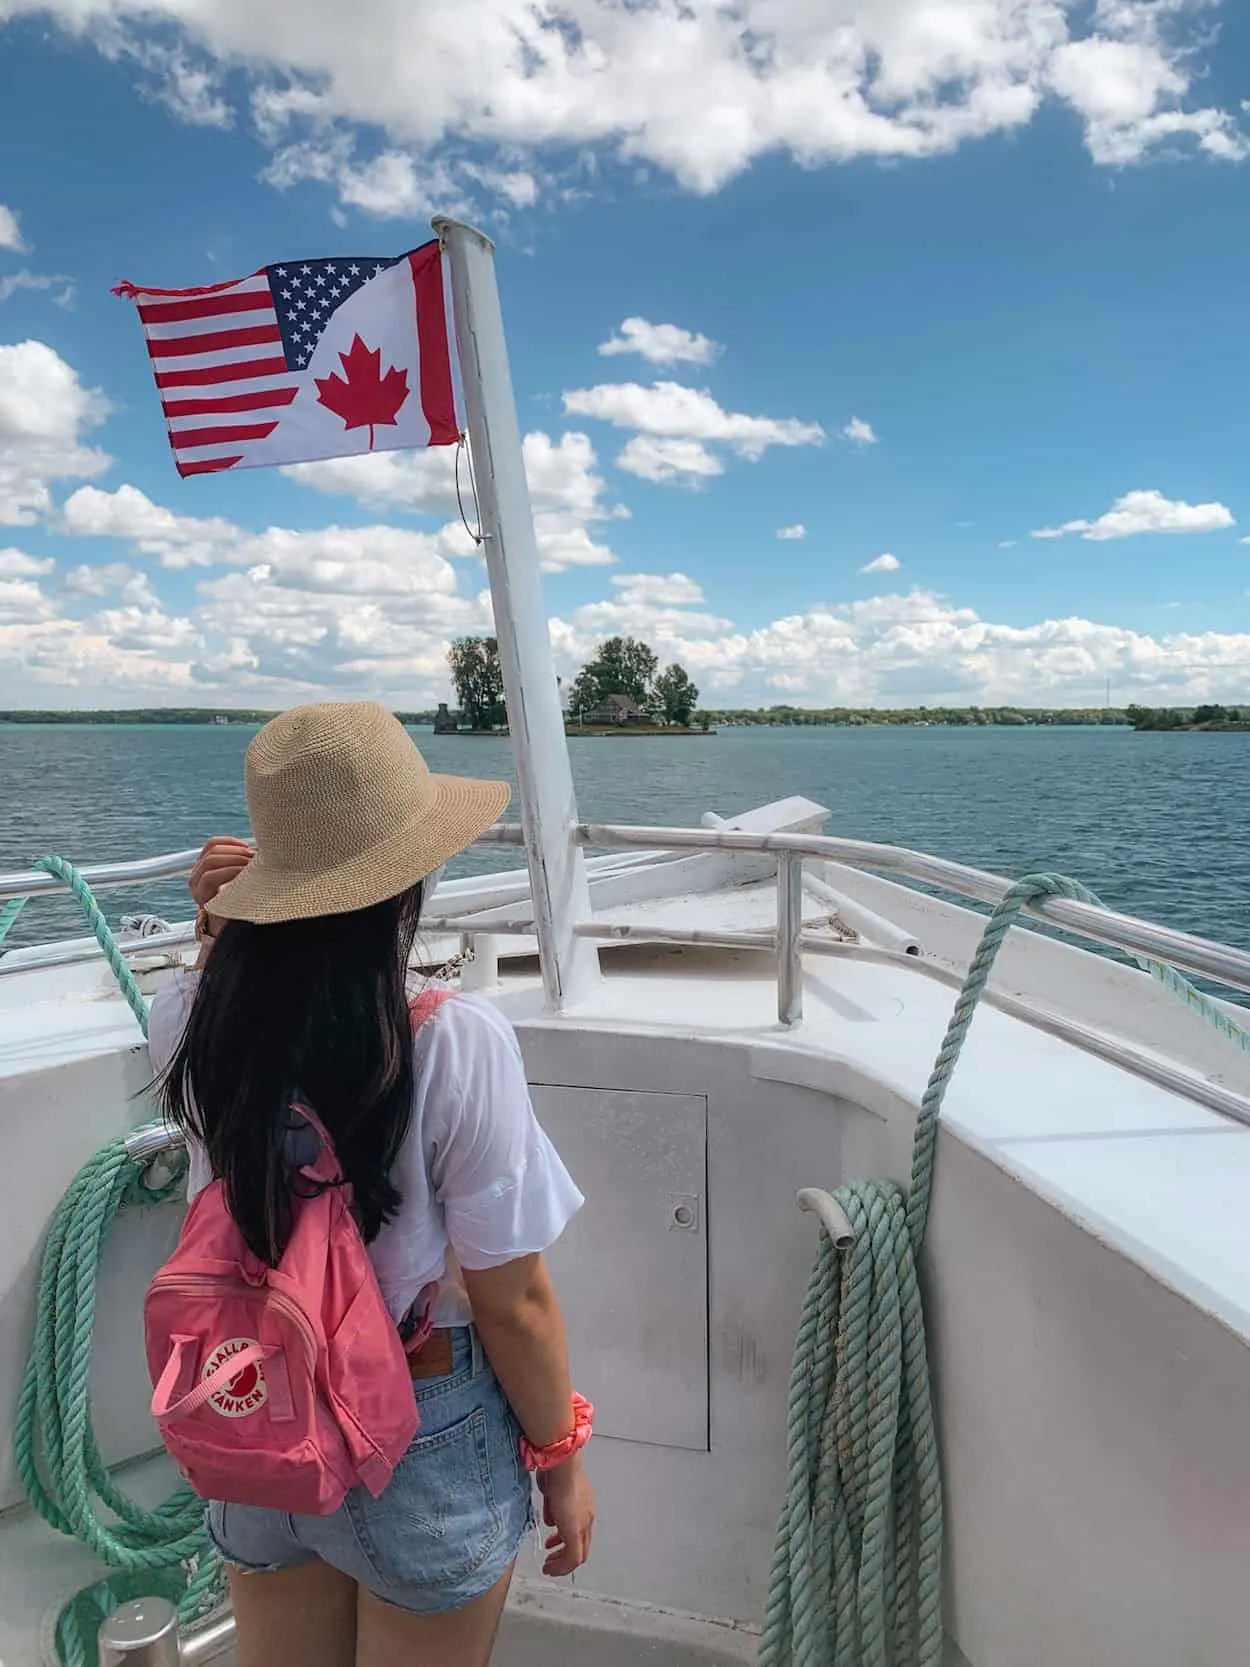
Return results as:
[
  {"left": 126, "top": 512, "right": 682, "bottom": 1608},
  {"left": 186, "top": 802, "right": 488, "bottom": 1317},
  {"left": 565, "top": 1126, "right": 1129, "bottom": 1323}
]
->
[{"left": 230, "top": 1560, "right": 357, "bottom": 1667}]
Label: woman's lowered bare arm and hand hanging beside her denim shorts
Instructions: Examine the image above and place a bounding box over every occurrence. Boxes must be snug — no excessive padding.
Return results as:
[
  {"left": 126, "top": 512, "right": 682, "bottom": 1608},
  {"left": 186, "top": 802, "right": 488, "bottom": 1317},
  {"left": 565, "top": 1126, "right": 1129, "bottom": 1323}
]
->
[{"left": 462, "top": 1255, "right": 595, "bottom": 1575}]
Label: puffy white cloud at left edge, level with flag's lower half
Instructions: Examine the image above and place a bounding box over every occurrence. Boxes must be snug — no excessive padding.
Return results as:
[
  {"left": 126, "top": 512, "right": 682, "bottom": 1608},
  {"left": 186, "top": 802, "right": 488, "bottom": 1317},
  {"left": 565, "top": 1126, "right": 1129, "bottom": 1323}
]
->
[{"left": 0, "top": 342, "right": 110, "bottom": 527}]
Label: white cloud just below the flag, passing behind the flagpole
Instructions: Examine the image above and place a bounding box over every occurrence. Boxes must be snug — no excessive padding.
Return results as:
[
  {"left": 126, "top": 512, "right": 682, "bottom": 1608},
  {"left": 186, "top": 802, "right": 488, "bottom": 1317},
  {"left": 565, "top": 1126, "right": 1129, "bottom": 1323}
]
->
[{"left": 283, "top": 430, "right": 628, "bottom": 573}]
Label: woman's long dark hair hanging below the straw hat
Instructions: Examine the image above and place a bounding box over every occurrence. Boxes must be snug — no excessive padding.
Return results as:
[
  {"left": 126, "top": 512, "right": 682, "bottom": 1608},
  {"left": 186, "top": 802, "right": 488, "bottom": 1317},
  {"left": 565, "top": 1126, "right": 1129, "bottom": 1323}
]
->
[{"left": 160, "top": 884, "right": 422, "bottom": 1267}]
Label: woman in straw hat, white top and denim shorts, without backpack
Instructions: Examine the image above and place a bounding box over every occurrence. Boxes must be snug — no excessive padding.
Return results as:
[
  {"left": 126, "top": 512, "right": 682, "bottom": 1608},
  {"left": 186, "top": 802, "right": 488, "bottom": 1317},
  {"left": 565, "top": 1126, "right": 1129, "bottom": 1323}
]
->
[{"left": 150, "top": 703, "right": 593, "bottom": 1667}]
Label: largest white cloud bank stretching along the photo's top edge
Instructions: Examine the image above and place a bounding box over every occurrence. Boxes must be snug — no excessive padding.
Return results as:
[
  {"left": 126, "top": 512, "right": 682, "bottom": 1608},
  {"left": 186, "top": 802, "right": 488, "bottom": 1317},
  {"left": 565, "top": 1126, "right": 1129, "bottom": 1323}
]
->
[{"left": 7, "top": 0, "right": 1245, "bottom": 212}]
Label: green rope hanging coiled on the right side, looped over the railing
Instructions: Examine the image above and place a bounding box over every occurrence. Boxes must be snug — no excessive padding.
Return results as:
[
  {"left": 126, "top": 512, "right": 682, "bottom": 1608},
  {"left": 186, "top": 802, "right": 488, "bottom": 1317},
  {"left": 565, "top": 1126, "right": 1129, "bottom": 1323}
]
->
[{"left": 758, "top": 874, "right": 1250, "bottom": 1667}]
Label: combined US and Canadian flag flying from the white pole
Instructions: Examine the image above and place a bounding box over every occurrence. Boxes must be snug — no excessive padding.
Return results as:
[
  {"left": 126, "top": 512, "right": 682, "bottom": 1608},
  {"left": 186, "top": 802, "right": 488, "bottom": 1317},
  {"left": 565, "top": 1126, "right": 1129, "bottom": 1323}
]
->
[{"left": 115, "top": 242, "right": 460, "bottom": 477}]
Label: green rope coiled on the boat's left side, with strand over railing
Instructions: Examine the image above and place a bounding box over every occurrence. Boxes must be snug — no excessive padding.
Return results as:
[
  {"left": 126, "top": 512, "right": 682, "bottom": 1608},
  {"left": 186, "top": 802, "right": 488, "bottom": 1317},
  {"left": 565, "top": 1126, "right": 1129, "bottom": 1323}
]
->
[{"left": 13, "top": 857, "right": 222, "bottom": 1667}]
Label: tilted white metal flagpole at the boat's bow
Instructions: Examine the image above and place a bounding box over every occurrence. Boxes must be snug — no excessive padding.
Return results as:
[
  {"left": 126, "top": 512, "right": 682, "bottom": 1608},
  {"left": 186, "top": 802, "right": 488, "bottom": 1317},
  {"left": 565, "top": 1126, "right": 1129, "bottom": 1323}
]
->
[{"left": 433, "top": 215, "right": 598, "bottom": 1012}]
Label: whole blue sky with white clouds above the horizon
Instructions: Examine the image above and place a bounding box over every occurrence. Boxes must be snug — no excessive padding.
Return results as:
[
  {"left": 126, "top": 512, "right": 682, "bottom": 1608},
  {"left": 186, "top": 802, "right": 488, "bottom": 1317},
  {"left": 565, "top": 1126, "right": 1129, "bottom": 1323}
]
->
[{"left": 0, "top": 0, "right": 1250, "bottom": 707}]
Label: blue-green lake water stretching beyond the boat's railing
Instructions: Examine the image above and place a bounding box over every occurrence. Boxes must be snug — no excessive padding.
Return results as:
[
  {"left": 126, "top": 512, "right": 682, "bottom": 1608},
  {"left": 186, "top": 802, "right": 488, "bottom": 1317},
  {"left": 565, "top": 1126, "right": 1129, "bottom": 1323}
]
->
[{"left": 0, "top": 725, "right": 1250, "bottom": 949}]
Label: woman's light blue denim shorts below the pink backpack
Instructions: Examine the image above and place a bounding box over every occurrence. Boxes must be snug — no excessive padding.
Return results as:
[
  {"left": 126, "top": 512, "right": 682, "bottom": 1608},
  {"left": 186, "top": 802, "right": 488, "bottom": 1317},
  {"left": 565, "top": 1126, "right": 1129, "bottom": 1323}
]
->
[{"left": 208, "top": 1325, "right": 533, "bottom": 1615}]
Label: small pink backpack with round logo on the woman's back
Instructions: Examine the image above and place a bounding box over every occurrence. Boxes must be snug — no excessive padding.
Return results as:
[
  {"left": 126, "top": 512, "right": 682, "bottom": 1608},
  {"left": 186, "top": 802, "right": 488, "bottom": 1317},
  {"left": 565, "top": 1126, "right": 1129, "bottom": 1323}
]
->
[{"left": 143, "top": 990, "right": 450, "bottom": 1517}]
